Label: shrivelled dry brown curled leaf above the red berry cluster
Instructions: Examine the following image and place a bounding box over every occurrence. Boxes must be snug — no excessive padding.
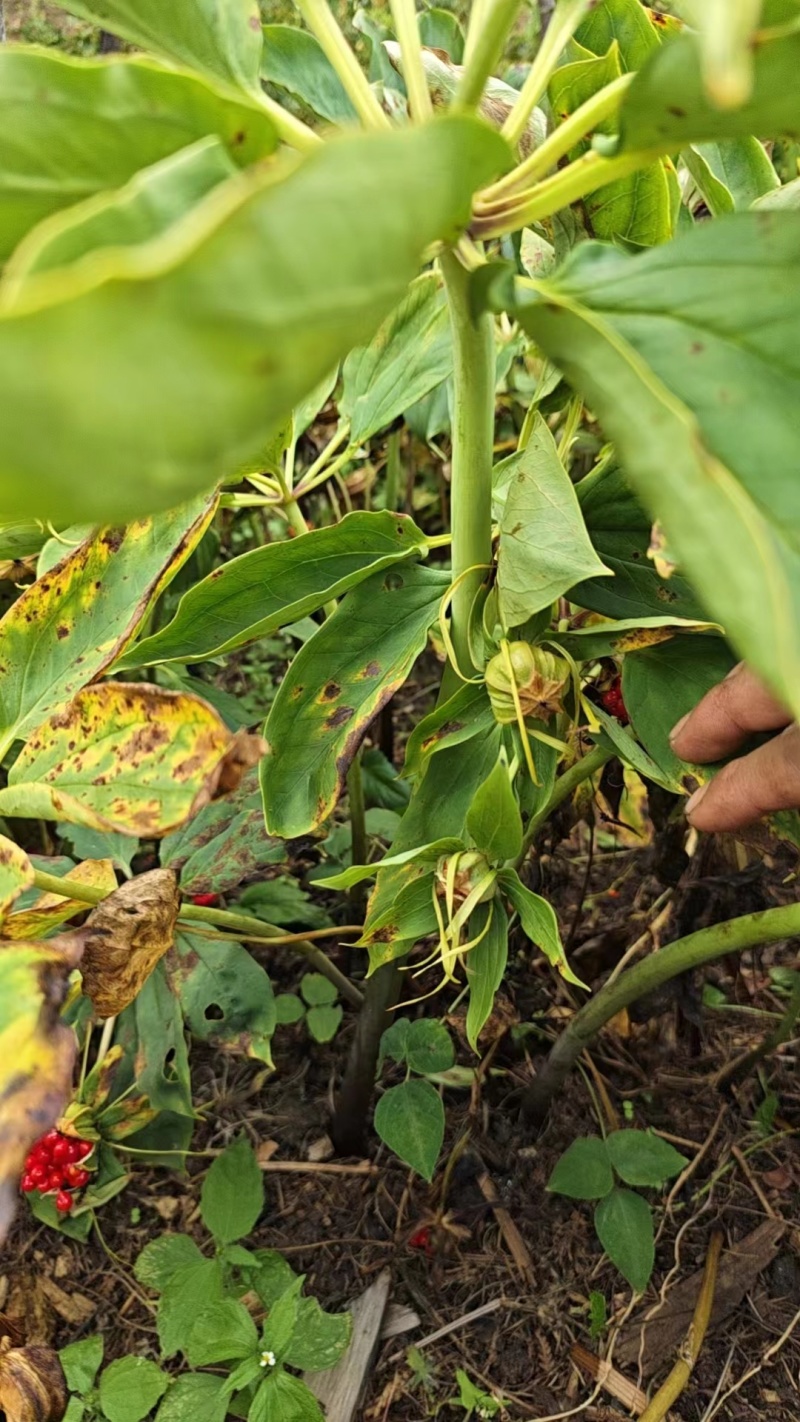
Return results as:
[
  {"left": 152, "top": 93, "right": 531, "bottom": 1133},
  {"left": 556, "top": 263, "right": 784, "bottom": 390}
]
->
[{"left": 80, "top": 869, "right": 180, "bottom": 1017}]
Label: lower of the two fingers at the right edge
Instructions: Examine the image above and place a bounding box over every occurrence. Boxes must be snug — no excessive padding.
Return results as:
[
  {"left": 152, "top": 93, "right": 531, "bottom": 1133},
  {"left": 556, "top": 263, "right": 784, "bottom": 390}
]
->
[{"left": 686, "top": 725, "right": 800, "bottom": 832}]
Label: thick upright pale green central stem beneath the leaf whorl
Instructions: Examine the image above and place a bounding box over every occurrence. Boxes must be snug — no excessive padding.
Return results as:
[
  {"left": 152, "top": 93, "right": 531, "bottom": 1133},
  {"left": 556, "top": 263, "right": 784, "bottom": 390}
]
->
[{"left": 440, "top": 252, "right": 494, "bottom": 671}]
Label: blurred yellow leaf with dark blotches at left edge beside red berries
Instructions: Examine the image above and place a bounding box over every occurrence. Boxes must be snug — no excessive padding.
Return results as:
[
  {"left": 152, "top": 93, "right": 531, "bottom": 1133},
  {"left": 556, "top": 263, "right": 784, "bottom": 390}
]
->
[{"left": 0, "top": 934, "right": 81, "bottom": 1245}]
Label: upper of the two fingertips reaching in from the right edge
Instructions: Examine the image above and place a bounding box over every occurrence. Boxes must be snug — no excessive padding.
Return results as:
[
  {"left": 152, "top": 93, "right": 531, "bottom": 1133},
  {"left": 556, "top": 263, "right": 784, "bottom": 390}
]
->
[{"left": 669, "top": 661, "right": 791, "bottom": 765}]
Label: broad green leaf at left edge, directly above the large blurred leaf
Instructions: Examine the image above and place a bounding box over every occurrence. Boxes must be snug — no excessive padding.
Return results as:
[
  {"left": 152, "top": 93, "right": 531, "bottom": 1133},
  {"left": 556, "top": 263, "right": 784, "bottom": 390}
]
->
[{"left": 0, "top": 46, "right": 276, "bottom": 260}]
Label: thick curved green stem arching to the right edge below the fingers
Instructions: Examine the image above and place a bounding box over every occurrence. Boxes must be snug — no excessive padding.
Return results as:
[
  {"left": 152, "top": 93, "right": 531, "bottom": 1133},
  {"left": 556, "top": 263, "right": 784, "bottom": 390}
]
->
[{"left": 523, "top": 898, "right": 800, "bottom": 1123}]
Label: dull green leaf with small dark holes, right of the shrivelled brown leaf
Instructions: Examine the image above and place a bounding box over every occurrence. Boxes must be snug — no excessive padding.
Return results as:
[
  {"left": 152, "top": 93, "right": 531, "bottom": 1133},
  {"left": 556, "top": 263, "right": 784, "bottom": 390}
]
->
[{"left": 166, "top": 934, "right": 277, "bottom": 1067}]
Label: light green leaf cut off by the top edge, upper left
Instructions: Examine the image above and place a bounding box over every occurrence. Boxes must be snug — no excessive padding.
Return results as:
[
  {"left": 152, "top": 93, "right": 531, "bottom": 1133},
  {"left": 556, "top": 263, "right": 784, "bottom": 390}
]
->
[{"left": 55, "top": 0, "right": 261, "bottom": 92}]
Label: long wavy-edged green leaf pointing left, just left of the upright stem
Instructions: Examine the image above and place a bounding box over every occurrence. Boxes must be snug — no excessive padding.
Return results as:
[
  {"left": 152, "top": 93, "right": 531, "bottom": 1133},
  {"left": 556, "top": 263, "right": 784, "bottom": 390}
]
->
[{"left": 118, "top": 512, "right": 425, "bottom": 670}]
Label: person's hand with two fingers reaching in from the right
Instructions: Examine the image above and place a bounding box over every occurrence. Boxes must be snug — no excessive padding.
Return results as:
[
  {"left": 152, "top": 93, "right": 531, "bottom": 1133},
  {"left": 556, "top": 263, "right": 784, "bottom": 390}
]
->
[{"left": 669, "top": 661, "right": 800, "bottom": 830}]
